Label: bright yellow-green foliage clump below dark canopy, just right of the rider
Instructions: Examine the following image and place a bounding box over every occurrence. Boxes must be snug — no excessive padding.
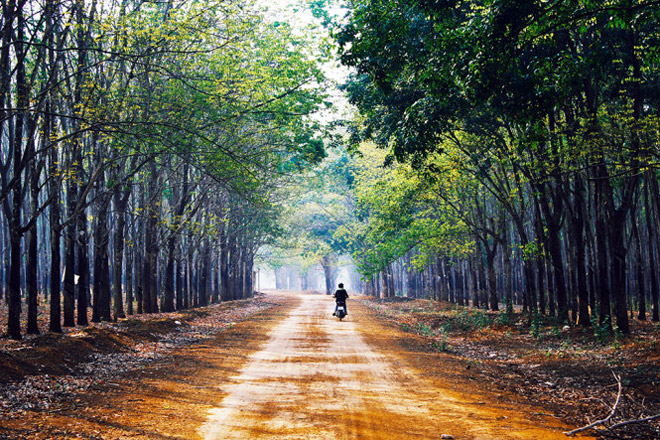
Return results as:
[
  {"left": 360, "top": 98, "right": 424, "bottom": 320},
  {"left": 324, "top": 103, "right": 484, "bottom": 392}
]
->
[{"left": 342, "top": 143, "right": 473, "bottom": 276}]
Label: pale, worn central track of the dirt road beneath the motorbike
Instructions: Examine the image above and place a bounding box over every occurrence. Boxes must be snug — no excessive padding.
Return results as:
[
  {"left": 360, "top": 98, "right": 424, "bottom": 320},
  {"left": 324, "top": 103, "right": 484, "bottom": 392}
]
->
[{"left": 202, "top": 295, "right": 588, "bottom": 440}]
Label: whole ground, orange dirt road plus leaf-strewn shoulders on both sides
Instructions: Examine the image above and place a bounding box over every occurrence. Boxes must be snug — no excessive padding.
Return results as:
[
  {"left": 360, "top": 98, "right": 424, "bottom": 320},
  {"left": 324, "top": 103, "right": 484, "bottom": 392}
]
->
[{"left": 0, "top": 294, "right": 660, "bottom": 439}]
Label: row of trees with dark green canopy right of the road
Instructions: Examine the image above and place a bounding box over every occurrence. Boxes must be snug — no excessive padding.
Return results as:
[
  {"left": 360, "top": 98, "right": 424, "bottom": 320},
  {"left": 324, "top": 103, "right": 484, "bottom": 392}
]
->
[{"left": 337, "top": 0, "right": 660, "bottom": 333}]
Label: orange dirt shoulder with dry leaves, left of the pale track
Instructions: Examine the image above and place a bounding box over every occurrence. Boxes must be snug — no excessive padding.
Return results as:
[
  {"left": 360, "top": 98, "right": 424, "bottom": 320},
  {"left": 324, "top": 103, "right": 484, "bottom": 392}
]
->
[{"left": 0, "top": 296, "right": 296, "bottom": 439}]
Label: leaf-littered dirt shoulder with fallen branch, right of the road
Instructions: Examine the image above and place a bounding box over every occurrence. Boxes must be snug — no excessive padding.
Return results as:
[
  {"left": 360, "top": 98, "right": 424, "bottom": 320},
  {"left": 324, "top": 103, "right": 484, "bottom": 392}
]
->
[{"left": 360, "top": 298, "right": 660, "bottom": 439}]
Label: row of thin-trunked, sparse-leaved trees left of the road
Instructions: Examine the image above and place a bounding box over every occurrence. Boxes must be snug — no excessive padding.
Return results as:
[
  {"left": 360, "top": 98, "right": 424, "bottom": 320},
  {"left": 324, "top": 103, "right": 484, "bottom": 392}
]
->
[{"left": 0, "top": 0, "right": 324, "bottom": 338}]
